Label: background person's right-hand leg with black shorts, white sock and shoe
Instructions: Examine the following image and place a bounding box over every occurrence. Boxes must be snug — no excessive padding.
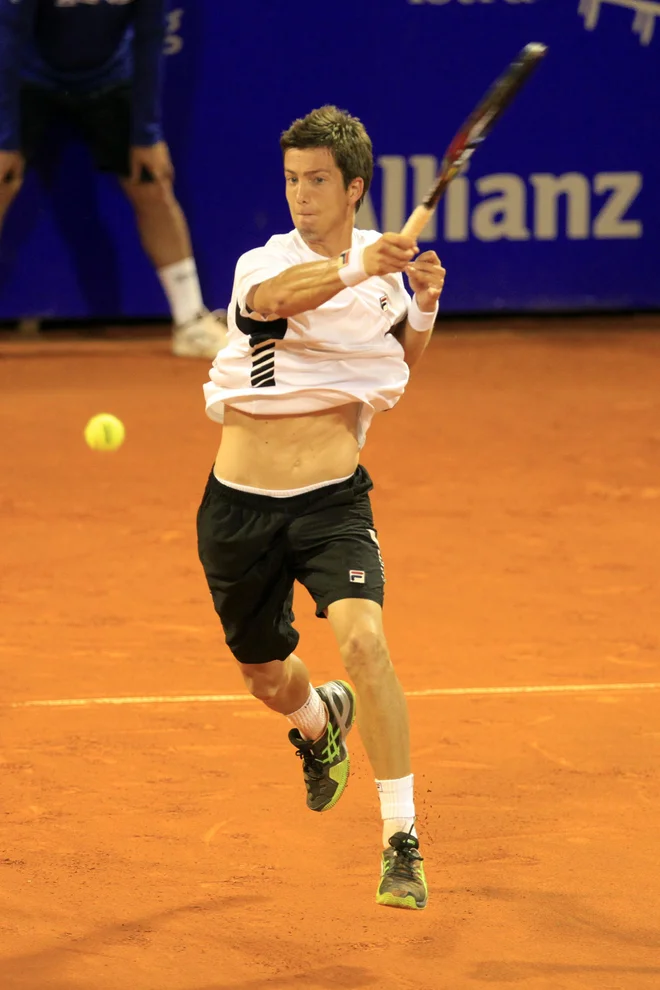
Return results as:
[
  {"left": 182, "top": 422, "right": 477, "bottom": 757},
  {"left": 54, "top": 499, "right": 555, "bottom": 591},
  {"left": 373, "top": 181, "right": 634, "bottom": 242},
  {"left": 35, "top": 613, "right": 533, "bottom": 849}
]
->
[{"left": 72, "top": 86, "right": 226, "bottom": 359}]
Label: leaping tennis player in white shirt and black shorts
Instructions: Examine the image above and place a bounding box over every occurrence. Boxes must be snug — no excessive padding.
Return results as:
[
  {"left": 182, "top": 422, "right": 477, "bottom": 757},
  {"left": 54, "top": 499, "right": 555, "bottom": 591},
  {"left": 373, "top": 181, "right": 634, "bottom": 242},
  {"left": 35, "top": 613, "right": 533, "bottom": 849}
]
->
[{"left": 198, "top": 106, "right": 445, "bottom": 909}]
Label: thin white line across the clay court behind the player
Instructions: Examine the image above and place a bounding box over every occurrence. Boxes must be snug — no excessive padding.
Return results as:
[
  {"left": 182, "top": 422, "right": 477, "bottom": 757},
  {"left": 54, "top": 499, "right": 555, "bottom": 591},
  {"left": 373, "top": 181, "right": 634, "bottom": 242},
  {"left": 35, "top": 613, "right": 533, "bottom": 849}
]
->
[{"left": 6, "top": 681, "right": 660, "bottom": 708}]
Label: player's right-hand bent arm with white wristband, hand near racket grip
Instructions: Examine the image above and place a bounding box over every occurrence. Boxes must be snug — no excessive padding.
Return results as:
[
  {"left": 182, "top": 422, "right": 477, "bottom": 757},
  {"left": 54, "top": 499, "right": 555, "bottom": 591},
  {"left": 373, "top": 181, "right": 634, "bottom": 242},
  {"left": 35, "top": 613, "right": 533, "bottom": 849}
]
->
[{"left": 394, "top": 251, "right": 447, "bottom": 368}]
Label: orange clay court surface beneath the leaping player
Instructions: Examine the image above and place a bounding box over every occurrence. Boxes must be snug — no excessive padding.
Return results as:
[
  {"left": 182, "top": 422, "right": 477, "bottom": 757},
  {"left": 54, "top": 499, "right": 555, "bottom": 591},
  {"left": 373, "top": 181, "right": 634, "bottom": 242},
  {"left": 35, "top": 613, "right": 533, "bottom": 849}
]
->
[{"left": 0, "top": 316, "right": 660, "bottom": 990}]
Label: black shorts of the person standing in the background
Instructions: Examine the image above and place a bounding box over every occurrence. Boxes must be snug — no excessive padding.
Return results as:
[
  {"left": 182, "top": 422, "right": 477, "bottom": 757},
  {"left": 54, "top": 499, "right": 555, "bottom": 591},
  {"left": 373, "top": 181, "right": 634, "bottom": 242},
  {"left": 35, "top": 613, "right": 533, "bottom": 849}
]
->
[{"left": 21, "top": 83, "right": 133, "bottom": 176}]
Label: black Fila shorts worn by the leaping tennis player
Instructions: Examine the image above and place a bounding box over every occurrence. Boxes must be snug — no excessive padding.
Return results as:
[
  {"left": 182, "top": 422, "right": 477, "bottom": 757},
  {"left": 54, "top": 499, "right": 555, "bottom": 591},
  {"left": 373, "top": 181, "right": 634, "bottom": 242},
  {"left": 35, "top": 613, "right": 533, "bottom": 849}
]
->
[{"left": 197, "top": 466, "right": 385, "bottom": 663}]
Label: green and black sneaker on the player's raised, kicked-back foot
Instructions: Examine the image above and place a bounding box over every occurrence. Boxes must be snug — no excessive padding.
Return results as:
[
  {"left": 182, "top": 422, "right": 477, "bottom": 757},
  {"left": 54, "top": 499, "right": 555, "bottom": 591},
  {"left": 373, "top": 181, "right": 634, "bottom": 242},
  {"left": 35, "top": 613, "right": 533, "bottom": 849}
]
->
[{"left": 289, "top": 681, "right": 355, "bottom": 811}]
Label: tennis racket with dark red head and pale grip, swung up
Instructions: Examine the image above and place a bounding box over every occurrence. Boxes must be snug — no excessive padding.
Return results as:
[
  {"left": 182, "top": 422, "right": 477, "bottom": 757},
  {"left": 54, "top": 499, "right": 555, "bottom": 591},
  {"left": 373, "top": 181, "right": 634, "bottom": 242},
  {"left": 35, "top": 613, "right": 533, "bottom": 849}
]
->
[{"left": 401, "top": 42, "right": 548, "bottom": 239}]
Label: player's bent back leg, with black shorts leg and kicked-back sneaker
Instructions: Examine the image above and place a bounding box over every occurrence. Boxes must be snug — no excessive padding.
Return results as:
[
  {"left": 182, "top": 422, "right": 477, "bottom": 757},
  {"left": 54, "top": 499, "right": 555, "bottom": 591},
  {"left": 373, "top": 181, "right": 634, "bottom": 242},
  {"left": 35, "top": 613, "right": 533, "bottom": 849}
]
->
[{"left": 197, "top": 475, "right": 354, "bottom": 811}]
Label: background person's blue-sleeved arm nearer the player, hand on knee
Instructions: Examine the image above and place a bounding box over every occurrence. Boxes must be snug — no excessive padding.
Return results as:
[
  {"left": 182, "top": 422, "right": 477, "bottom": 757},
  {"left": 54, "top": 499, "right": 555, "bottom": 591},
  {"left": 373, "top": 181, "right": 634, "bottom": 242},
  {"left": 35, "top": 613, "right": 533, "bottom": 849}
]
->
[{"left": 131, "top": 0, "right": 173, "bottom": 182}]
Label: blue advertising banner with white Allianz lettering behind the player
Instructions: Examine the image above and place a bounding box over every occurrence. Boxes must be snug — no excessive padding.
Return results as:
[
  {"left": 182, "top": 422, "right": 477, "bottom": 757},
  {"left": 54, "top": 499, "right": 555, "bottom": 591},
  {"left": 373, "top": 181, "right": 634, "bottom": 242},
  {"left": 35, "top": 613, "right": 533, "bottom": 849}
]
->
[{"left": 0, "top": 0, "right": 660, "bottom": 318}]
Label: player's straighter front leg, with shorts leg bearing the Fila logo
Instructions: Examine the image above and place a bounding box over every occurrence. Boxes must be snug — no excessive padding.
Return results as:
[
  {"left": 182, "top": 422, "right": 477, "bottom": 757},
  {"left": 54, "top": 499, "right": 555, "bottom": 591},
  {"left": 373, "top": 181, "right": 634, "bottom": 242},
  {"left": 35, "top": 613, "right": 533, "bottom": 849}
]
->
[{"left": 295, "top": 467, "right": 428, "bottom": 908}]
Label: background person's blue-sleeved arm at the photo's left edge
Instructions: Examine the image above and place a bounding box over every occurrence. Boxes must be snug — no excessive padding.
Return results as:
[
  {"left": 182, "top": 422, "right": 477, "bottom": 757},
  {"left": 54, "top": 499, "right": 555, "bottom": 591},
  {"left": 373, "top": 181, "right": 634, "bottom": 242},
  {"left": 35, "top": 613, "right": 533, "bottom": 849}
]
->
[{"left": 0, "top": 0, "right": 37, "bottom": 183}]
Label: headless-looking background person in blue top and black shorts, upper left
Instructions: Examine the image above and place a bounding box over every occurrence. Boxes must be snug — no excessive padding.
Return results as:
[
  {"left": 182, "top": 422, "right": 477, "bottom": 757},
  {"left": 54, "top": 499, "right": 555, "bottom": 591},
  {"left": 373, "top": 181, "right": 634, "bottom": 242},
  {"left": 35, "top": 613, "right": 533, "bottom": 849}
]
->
[{"left": 0, "top": 0, "right": 226, "bottom": 359}]
